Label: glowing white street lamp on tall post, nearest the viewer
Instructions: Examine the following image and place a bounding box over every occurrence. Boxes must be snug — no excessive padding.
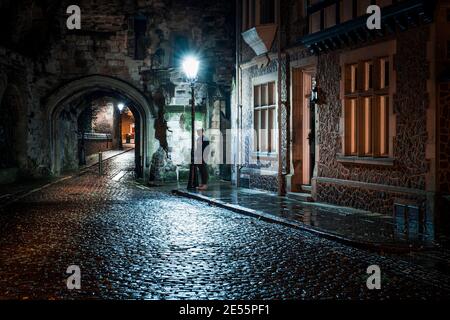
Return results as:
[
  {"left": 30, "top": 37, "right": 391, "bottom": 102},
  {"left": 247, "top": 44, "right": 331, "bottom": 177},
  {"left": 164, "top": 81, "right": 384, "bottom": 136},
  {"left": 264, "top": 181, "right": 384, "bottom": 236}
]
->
[{"left": 182, "top": 56, "right": 200, "bottom": 189}]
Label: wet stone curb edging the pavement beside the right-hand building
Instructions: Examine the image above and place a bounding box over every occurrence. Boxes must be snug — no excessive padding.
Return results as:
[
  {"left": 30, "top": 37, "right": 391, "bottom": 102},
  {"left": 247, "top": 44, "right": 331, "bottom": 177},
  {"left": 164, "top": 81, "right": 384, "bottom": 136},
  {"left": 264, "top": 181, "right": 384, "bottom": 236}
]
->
[{"left": 172, "top": 190, "right": 429, "bottom": 254}]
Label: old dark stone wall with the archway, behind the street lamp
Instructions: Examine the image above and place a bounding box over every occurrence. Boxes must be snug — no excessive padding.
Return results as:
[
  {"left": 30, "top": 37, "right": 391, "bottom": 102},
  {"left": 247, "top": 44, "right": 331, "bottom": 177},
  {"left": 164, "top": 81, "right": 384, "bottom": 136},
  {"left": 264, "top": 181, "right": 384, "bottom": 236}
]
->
[{"left": 0, "top": 0, "right": 235, "bottom": 184}]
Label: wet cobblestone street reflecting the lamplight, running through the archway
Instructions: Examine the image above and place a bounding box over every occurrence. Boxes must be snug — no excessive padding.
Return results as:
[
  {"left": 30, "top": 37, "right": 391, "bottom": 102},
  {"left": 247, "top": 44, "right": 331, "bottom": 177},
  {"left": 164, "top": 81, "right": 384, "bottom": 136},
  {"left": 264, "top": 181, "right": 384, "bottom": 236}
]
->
[{"left": 0, "top": 152, "right": 450, "bottom": 299}]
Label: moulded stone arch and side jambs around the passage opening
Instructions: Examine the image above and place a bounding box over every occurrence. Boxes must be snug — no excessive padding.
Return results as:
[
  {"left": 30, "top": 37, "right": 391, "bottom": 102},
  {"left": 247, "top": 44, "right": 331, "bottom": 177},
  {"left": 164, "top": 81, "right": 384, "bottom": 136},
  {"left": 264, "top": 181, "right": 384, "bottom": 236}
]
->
[{"left": 46, "top": 75, "right": 156, "bottom": 179}]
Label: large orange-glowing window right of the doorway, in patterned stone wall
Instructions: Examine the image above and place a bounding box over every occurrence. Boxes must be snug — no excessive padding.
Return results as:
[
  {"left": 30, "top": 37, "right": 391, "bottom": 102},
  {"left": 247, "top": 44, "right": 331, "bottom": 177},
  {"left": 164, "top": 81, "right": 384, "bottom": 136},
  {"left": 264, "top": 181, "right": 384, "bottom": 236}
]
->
[{"left": 344, "top": 57, "right": 391, "bottom": 157}]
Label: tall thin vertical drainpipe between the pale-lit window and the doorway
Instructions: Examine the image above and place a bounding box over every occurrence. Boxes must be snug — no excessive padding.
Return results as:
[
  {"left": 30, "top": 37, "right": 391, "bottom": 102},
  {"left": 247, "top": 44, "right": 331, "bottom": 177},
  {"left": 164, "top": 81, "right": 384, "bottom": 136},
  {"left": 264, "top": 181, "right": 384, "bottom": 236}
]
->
[{"left": 277, "top": 0, "right": 286, "bottom": 196}]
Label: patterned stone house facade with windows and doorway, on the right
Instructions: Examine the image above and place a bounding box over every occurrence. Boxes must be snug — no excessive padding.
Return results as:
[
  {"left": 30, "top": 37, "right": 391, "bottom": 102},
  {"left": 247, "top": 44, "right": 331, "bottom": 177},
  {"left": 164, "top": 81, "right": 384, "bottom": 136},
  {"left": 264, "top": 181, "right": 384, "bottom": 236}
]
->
[{"left": 232, "top": 0, "right": 450, "bottom": 223}]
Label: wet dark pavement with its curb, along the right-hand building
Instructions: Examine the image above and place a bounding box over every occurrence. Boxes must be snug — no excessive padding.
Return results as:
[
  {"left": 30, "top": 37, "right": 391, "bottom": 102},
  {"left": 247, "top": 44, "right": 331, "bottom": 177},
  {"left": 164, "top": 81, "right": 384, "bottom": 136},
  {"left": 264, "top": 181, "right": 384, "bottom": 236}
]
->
[{"left": 173, "top": 181, "right": 440, "bottom": 252}]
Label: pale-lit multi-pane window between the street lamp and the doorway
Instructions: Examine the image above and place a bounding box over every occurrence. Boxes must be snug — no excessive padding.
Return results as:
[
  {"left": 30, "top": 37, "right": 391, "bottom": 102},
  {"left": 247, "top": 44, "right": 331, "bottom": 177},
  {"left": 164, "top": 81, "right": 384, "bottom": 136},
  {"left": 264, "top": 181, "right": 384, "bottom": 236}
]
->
[{"left": 253, "top": 82, "right": 276, "bottom": 153}]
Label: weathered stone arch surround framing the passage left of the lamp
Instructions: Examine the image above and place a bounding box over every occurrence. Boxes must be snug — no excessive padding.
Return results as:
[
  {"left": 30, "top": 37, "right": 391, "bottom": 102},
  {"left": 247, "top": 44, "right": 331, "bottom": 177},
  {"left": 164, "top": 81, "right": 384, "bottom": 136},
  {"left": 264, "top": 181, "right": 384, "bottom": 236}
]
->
[{"left": 45, "top": 75, "right": 157, "bottom": 179}]
